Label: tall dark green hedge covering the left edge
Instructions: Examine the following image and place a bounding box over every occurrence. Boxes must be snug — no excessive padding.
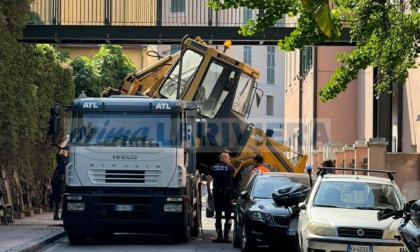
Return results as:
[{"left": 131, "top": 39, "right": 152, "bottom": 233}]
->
[{"left": 0, "top": 0, "right": 74, "bottom": 209}]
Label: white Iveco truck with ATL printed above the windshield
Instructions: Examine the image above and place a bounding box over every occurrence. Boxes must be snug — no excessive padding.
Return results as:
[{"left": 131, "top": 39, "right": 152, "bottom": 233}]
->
[{"left": 49, "top": 95, "right": 207, "bottom": 244}]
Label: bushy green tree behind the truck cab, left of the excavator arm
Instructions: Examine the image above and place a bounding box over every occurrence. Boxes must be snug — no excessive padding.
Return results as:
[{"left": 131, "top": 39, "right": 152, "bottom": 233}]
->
[{"left": 71, "top": 45, "right": 136, "bottom": 97}]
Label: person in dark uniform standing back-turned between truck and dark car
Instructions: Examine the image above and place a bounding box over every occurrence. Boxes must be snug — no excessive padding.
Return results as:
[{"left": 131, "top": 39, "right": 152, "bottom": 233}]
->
[{"left": 207, "top": 153, "right": 235, "bottom": 242}]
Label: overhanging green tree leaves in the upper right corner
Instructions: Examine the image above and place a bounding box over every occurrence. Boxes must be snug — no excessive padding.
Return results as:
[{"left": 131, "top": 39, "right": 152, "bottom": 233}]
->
[{"left": 209, "top": 0, "right": 420, "bottom": 101}]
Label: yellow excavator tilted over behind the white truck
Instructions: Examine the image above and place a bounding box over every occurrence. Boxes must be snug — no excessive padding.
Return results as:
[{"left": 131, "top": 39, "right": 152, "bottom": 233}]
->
[{"left": 102, "top": 36, "right": 308, "bottom": 189}]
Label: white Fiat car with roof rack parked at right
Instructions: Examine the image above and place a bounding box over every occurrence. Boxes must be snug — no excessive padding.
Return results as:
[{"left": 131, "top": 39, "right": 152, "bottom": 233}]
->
[{"left": 298, "top": 168, "right": 404, "bottom": 252}]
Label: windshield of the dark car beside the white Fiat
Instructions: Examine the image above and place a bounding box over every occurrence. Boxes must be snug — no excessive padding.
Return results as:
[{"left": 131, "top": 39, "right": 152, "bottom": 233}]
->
[{"left": 252, "top": 177, "right": 292, "bottom": 199}]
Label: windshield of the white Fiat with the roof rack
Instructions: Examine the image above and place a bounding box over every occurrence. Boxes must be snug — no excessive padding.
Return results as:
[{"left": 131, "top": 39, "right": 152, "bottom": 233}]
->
[{"left": 314, "top": 181, "right": 403, "bottom": 210}]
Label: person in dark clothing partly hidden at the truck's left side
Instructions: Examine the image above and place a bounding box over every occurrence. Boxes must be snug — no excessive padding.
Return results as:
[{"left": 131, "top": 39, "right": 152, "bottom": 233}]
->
[{"left": 50, "top": 137, "right": 68, "bottom": 220}]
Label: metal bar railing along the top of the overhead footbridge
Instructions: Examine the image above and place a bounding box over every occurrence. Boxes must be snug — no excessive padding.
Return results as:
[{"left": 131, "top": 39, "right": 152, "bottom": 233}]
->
[{"left": 31, "top": 0, "right": 296, "bottom": 27}]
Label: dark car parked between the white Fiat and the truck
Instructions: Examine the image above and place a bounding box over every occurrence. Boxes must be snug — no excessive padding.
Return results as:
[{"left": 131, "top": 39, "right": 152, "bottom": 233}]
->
[{"left": 233, "top": 172, "right": 315, "bottom": 251}]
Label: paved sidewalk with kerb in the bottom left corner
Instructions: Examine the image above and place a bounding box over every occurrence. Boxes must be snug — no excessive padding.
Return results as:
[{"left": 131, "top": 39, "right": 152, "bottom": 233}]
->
[{"left": 0, "top": 209, "right": 65, "bottom": 252}]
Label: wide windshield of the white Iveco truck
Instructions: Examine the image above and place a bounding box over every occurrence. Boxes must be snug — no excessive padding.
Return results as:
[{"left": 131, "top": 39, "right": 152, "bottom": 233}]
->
[{"left": 70, "top": 112, "right": 181, "bottom": 147}]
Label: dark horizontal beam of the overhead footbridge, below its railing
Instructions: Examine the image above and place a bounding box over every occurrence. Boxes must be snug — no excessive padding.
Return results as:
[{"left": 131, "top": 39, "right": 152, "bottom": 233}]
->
[{"left": 20, "top": 25, "right": 351, "bottom": 45}]
